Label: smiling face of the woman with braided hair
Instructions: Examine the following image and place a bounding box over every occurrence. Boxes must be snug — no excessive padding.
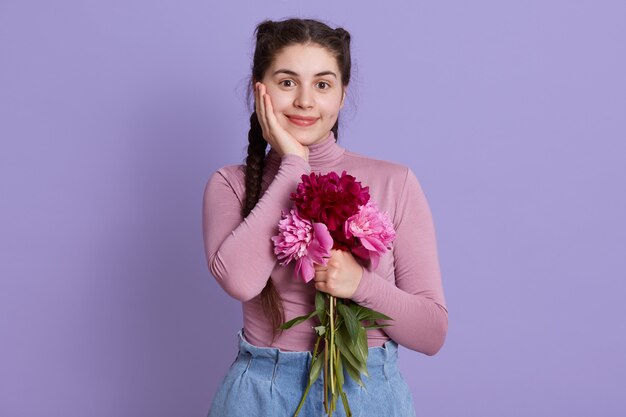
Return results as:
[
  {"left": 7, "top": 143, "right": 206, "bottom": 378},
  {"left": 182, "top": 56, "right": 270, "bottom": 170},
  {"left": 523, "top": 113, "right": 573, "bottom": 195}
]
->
[{"left": 261, "top": 44, "right": 345, "bottom": 146}]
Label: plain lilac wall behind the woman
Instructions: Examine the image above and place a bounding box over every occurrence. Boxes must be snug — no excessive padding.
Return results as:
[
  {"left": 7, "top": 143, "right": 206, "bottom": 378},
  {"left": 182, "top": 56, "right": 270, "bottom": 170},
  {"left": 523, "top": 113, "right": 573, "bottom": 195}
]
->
[{"left": 0, "top": 0, "right": 626, "bottom": 417}]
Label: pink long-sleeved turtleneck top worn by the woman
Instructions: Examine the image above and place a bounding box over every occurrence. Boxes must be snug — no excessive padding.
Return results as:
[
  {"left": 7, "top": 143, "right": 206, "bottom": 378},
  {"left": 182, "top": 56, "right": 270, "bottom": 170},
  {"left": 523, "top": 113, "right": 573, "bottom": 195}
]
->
[{"left": 202, "top": 131, "right": 448, "bottom": 355}]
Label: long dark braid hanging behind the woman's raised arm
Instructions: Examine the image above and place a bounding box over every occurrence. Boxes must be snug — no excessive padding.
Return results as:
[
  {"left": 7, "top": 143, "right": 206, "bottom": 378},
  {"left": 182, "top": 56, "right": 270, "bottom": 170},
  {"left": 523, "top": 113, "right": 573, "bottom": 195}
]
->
[{"left": 242, "top": 112, "right": 285, "bottom": 342}]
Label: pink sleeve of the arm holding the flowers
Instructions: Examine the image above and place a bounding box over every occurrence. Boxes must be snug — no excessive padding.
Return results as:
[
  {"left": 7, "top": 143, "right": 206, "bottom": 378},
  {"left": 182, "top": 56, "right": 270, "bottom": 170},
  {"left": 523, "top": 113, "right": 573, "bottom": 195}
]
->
[{"left": 352, "top": 168, "right": 448, "bottom": 356}]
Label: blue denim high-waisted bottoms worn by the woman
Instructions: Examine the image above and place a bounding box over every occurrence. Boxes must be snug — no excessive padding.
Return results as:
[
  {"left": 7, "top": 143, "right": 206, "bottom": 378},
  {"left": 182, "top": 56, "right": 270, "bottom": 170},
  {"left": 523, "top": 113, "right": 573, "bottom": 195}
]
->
[{"left": 209, "top": 329, "right": 415, "bottom": 417}]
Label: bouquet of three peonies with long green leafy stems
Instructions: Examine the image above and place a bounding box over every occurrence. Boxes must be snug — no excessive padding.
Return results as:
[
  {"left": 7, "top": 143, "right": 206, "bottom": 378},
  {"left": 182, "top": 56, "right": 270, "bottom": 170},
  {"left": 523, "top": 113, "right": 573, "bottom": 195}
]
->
[{"left": 271, "top": 171, "right": 395, "bottom": 417}]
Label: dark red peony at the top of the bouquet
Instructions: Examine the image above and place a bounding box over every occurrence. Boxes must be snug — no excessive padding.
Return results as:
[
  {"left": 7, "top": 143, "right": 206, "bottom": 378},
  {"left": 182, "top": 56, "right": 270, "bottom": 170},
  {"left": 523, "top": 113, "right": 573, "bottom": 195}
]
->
[{"left": 291, "top": 171, "right": 370, "bottom": 249}]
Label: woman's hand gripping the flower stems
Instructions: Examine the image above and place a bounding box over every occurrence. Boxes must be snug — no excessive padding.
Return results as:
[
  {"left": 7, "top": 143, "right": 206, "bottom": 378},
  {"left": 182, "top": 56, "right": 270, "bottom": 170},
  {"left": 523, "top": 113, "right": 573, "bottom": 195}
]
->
[{"left": 313, "top": 249, "right": 363, "bottom": 298}]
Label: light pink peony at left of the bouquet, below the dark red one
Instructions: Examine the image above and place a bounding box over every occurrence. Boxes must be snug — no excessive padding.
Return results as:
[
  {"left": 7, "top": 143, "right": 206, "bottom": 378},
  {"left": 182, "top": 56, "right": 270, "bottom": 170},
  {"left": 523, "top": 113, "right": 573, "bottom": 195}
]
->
[{"left": 271, "top": 209, "right": 333, "bottom": 282}]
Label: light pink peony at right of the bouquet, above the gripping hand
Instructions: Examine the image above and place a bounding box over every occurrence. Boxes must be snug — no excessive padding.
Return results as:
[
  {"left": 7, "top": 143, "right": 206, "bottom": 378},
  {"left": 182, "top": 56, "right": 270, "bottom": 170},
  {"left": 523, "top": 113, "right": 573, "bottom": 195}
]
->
[{"left": 344, "top": 202, "right": 396, "bottom": 268}]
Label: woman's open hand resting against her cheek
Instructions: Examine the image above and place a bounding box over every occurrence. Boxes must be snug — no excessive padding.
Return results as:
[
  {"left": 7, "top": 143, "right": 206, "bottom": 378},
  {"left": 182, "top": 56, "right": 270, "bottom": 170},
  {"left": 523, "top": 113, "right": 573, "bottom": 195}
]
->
[{"left": 254, "top": 82, "right": 309, "bottom": 161}]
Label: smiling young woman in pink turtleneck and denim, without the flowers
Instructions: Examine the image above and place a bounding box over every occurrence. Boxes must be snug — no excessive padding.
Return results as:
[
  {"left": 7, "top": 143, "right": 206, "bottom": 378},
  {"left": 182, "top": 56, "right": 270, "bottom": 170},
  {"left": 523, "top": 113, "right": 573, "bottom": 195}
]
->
[{"left": 203, "top": 19, "right": 448, "bottom": 417}]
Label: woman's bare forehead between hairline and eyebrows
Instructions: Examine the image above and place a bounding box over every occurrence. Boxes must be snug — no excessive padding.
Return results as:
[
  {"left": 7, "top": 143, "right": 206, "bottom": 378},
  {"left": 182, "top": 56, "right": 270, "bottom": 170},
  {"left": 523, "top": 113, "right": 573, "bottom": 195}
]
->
[{"left": 270, "top": 44, "right": 339, "bottom": 77}]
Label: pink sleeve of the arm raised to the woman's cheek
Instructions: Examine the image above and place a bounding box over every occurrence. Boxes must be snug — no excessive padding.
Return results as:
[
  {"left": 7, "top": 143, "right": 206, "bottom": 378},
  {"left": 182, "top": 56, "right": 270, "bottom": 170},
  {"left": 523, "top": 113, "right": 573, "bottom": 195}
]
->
[{"left": 202, "top": 154, "right": 311, "bottom": 301}]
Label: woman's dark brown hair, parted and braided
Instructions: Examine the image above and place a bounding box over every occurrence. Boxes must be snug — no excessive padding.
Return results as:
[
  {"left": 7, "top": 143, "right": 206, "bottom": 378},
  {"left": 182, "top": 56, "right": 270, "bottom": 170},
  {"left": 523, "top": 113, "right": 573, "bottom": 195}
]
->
[{"left": 242, "top": 18, "right": 351, "bottom": 341}]
